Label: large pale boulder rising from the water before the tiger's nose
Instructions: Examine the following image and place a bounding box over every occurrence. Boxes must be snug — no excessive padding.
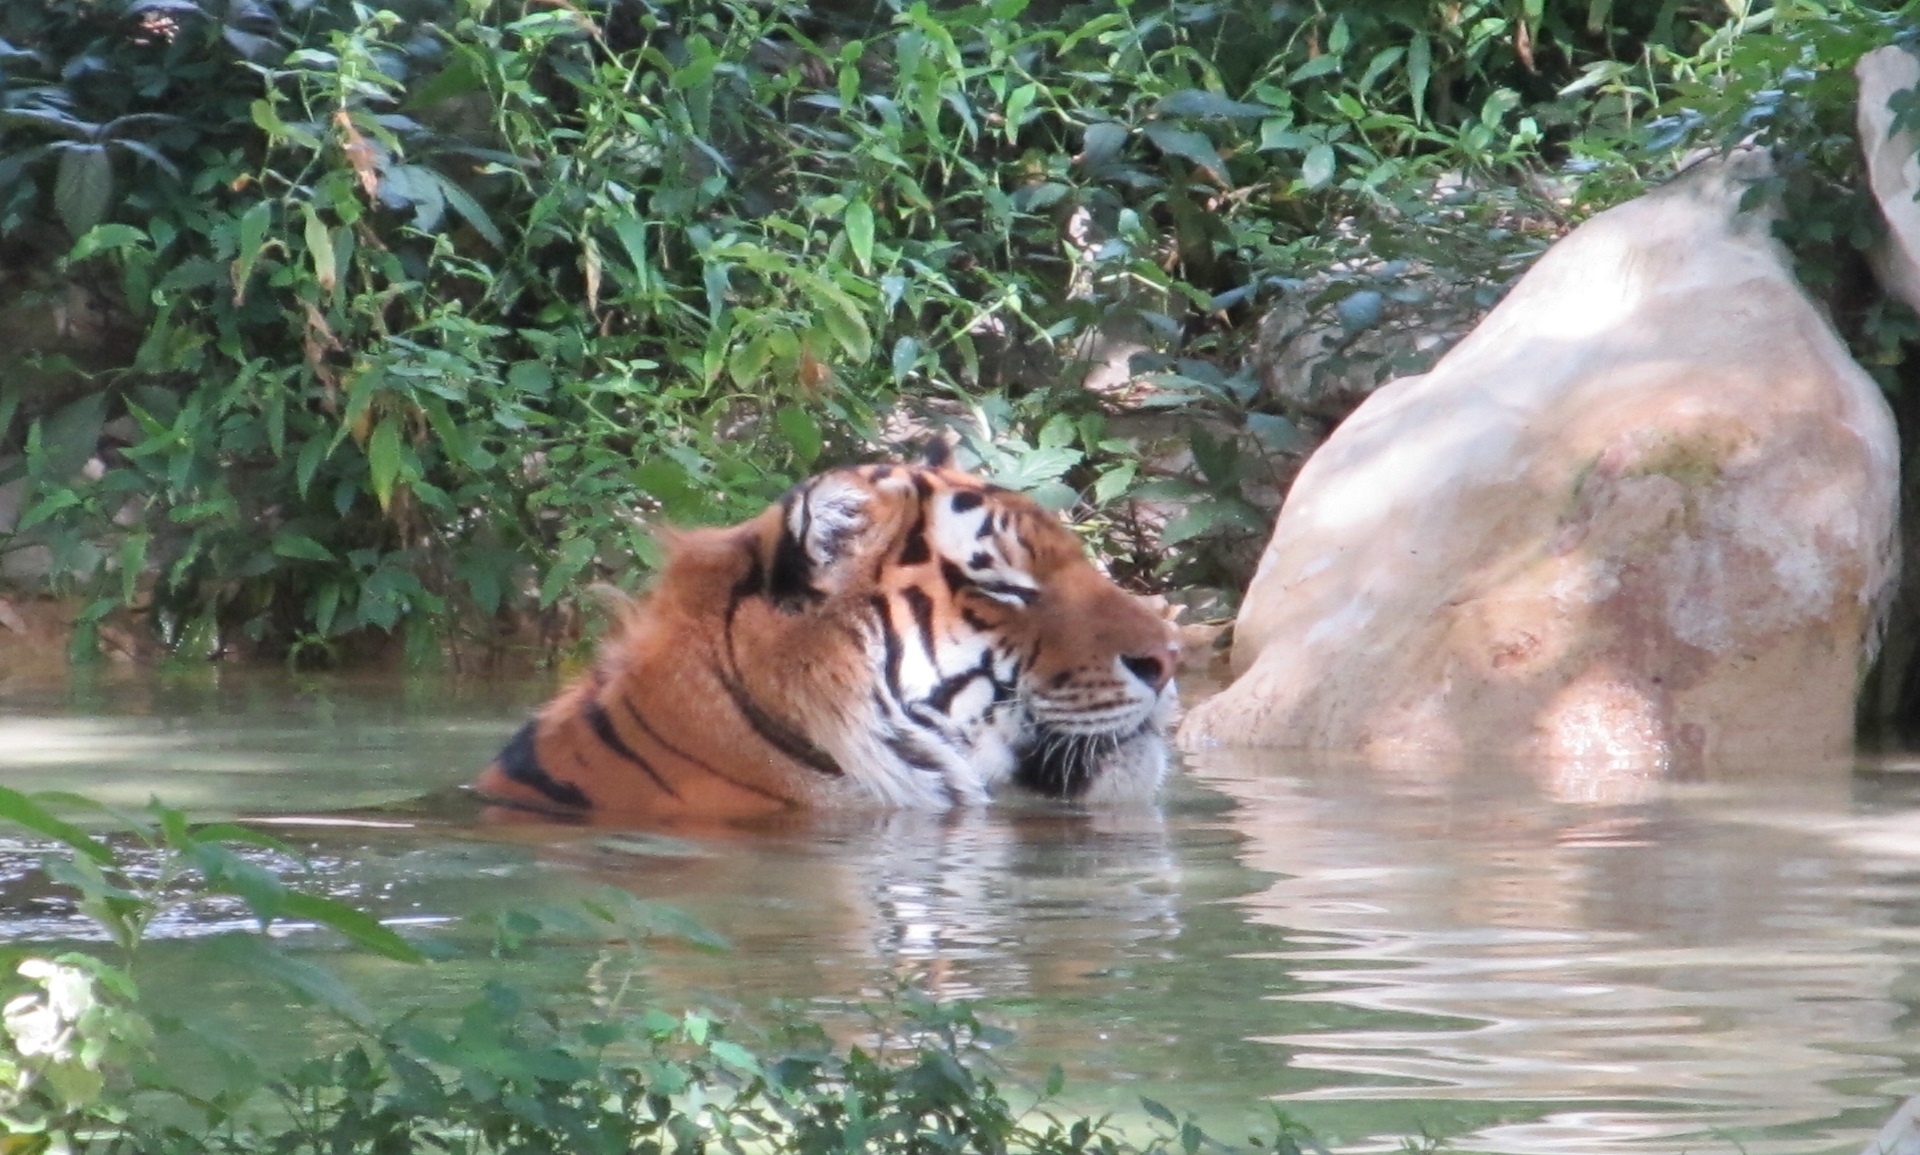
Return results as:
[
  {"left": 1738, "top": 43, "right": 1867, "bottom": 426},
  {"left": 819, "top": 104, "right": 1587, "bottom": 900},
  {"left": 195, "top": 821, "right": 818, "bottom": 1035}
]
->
[{"left": 1181, "top": 153, "right": 1897, "bottom": 764}]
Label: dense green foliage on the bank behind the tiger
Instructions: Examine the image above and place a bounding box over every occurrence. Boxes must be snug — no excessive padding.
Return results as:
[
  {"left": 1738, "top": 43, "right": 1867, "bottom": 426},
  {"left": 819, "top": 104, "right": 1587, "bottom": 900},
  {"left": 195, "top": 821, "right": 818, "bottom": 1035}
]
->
[{"left": 0, "top": 0, "right": 1899, "bottom": 658}]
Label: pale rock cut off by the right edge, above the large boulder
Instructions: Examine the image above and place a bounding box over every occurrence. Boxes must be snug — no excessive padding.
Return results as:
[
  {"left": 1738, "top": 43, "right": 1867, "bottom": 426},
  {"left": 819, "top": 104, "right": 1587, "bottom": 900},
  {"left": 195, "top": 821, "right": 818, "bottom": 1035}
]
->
[{"left": 1853, "top": 44, "right": 1920, "bottom": 311}]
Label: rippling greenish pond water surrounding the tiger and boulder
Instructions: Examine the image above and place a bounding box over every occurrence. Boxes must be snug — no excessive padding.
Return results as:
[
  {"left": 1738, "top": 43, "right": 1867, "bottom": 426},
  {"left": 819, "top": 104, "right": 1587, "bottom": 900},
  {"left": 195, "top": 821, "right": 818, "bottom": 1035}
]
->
[{"left": 0, "top": 670, "right": 1920, "bottom": 1153}]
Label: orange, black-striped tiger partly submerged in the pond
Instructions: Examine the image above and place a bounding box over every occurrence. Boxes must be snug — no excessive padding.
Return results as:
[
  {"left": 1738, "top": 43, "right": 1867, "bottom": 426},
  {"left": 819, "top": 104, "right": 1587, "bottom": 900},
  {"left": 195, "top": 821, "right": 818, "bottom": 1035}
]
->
[{"left": 474, "top": 445, "right": 1179, "bottom": 821}]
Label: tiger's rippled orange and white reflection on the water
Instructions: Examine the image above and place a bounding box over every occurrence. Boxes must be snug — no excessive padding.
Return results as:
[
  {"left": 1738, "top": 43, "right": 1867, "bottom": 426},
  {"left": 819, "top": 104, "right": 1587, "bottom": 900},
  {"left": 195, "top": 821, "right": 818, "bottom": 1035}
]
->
[{"left": 545, "top": 806, "right": 1181, "bottom": 1007}]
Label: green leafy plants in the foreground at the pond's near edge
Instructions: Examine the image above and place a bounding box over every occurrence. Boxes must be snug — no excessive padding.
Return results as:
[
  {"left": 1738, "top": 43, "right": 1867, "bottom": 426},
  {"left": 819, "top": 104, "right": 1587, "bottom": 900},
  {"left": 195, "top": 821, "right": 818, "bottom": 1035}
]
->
[{"left": 0, "top": 787, "right": 1319, "bottom": 1155}]
